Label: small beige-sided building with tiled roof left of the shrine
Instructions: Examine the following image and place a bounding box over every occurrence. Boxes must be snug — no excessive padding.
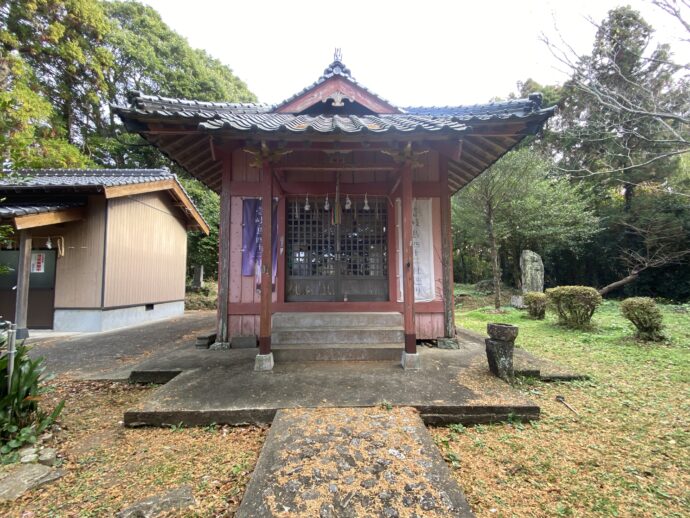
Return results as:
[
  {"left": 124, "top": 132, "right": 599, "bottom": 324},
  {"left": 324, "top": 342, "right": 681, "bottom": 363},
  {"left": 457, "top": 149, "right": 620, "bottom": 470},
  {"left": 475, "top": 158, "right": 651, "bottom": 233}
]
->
[{"left": 0, "top": 169, "right": 209, "bottom": 337}]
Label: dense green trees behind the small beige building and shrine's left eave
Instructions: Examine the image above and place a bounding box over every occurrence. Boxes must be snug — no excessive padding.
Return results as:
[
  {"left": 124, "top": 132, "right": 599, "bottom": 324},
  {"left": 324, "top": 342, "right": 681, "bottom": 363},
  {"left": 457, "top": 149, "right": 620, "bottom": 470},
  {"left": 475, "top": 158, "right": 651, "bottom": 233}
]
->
[{"left": 0, "top": 0, "right": 255, "bottom": 275}]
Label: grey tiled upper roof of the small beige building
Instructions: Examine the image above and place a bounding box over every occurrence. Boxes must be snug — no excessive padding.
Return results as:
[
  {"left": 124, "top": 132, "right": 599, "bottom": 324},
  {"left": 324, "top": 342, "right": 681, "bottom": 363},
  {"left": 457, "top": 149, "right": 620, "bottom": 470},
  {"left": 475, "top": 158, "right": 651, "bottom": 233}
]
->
[{"left": 0, "top": 169, "right": 177, "bottom": 189}]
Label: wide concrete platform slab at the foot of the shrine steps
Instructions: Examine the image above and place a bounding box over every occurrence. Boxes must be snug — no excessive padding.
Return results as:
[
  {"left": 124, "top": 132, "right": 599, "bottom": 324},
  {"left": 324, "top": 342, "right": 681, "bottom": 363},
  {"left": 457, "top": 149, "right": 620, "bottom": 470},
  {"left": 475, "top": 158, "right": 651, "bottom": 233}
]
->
[{"left": 124, "top": 349, "right": 539, "bottom": 426}]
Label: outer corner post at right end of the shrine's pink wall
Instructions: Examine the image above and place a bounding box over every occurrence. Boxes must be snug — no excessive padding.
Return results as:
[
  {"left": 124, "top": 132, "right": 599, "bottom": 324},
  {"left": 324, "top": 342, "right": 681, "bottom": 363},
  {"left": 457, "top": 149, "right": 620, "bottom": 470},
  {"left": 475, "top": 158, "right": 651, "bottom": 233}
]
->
[{"left": 439, "top": 157, "right": 455, "bottom": 338}]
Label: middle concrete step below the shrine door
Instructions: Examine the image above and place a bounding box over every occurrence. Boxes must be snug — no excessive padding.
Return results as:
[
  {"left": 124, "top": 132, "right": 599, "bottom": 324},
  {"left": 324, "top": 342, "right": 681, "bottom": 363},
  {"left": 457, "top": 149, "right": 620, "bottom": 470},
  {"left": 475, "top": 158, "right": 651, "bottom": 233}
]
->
[{"left": 271, "top": 327, "right": 405, "bottom": 345}]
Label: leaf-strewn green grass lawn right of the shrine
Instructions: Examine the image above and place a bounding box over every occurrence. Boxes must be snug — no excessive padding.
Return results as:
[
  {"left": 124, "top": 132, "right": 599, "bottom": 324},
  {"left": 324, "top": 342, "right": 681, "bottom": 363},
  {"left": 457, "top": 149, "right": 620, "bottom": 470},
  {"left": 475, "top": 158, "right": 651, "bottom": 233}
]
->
[{"left": 436, "top": 287, "right": 690, "bottom": 516}]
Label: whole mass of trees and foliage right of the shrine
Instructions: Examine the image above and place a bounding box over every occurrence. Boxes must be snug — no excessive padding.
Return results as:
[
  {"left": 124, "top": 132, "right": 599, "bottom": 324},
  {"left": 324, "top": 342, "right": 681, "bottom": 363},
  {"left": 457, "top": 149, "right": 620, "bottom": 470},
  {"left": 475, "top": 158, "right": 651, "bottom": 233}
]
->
[{"left": 454, "top": 7, "right": 690, "bottom": 301}]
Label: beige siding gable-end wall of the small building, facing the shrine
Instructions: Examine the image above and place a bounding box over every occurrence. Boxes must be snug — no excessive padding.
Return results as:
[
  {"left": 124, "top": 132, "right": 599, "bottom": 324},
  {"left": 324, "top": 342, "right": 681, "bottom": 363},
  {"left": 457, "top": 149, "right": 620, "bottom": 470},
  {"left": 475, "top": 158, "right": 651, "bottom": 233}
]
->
[{"left": 105, "top": 192, "right": 187, "bottom": 307}]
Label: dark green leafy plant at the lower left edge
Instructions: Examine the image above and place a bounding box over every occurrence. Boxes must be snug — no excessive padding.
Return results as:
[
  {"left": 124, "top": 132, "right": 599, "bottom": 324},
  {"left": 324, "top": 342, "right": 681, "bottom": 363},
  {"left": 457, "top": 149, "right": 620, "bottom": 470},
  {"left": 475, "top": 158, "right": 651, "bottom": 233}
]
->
[{"left": 0, "top": 345, "right": 64, "bottom": 462}]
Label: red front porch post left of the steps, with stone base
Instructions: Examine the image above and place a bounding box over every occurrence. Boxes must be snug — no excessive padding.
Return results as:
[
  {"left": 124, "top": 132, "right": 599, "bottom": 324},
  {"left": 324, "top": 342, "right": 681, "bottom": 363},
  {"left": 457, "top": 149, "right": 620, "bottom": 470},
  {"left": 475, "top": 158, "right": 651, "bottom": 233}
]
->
[{"left": 254, "top": 160, "right": 273, "bottom": 370}]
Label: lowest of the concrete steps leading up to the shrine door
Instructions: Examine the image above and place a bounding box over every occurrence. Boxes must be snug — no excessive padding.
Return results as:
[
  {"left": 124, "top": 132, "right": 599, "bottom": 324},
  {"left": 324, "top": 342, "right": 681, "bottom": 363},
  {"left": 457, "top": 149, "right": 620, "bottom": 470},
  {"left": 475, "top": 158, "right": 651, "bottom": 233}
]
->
[{"left": 271, "top": 344, "right": 404, "bottom": 363}]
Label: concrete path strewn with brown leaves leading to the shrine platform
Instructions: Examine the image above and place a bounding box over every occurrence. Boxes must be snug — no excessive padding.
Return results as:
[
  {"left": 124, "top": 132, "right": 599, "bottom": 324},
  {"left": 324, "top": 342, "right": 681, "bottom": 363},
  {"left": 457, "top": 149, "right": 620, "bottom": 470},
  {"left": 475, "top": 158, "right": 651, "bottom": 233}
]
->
[{"left": 235, "top": 407, "right": 473, "bottom": 518}]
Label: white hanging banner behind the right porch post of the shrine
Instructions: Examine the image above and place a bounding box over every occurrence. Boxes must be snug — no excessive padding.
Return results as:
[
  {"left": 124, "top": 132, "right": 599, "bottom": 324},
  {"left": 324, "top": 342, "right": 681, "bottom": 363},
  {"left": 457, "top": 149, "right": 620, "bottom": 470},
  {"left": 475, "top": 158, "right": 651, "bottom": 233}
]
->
[{"left": 395, "top": 198, "right": 436, "bottom": 302}]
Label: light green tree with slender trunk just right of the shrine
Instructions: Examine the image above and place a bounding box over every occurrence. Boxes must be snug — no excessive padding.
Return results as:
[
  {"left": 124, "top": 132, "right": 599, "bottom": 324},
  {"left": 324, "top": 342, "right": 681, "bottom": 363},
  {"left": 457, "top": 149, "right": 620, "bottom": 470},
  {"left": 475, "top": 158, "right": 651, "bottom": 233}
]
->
[{"left": 453, "top": 147, "right": 599, "bottom": 309}]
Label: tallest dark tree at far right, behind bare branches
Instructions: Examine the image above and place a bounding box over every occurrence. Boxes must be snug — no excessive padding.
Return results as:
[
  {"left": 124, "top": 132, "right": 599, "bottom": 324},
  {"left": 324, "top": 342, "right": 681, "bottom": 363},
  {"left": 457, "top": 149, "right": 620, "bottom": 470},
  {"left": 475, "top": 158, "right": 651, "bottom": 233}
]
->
[{"left": 544, "top": 5, "right": 690, "bottom": 295}]
